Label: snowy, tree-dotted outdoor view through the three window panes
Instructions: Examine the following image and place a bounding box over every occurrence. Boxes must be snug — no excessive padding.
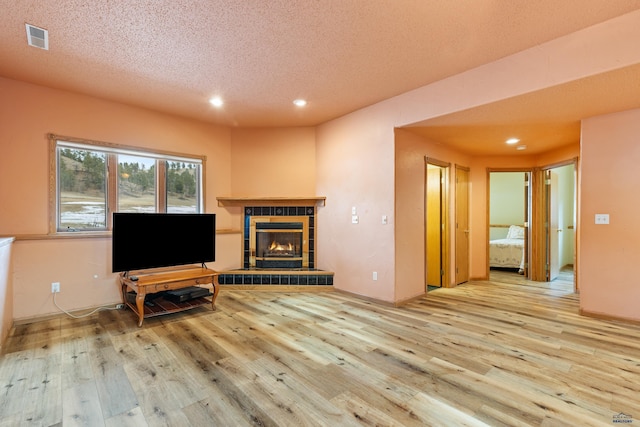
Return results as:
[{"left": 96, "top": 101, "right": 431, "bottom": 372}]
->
[{"left": 58, "top": 147, "right": 201, "bottom": 231}]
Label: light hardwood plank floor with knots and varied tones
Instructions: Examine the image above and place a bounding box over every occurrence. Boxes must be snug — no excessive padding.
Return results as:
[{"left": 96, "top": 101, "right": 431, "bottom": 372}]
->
[{"left": 0, "top": 273, "right": 640, "bottom": 427}]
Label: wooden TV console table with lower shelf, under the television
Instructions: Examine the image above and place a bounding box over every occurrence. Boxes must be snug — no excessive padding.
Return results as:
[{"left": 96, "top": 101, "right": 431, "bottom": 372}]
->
[{"left": 120, "top": 267, "right": 220, "bottom": 326}]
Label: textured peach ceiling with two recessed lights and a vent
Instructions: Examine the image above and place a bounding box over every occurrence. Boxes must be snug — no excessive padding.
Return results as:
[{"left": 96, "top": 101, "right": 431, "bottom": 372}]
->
[{"left": 0, "top": 0, "right": 640, "bottom": 154}]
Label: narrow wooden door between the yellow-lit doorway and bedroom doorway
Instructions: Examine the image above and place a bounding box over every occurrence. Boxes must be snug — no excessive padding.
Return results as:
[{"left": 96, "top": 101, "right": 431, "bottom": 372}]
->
[{"left": 456, "top": 166, "right": 469, "bottom": 285}]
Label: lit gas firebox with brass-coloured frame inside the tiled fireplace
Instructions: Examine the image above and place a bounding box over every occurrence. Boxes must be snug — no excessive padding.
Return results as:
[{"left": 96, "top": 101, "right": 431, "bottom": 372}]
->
[{"left": 256, "top": 222, "right": 303, "bottom": 268}]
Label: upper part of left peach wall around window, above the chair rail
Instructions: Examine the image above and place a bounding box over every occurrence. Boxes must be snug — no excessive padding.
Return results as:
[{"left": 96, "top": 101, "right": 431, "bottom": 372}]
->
[{"left": 0, "top": 78, "right": 231, "bottom": 235}]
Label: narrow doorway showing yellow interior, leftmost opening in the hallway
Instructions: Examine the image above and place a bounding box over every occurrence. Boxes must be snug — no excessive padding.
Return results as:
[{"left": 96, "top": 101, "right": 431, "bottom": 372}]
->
[{"left": 425, "top": 158, "right": 449, "bottom": 291}]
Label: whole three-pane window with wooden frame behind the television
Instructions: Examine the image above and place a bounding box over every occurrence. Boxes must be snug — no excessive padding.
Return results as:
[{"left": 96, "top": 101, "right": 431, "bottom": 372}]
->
[{"left": 49, "top": 135, "right": 205, "bottom": 232}]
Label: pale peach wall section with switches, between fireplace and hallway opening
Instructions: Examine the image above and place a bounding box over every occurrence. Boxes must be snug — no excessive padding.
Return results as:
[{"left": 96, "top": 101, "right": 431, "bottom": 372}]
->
[{"left": 316, "top": 107, "right": 395, "bottom": 301}]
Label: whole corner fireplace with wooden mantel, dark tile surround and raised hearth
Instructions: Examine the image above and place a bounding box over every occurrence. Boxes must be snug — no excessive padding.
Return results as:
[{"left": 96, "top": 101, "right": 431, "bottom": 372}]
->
[{"left": 218, "top": 198, "right": 333, "bottom": 286}]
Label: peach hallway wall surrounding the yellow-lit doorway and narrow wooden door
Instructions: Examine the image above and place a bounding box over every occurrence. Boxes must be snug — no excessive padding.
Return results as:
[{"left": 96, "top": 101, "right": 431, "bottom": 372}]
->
[{"left": 396, "top": 129, "right": 579, "bottom": 301}]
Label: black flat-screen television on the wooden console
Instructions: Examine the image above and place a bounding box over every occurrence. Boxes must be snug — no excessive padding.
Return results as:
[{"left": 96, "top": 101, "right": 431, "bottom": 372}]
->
[{"left": 112, "top": 212, "right": 216, "bottom": 272}]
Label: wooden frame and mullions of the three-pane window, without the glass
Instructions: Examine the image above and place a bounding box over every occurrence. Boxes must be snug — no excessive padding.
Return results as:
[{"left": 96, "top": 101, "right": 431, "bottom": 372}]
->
[{"left": 48, "top": 134, "right": 207, "bottom": 235}]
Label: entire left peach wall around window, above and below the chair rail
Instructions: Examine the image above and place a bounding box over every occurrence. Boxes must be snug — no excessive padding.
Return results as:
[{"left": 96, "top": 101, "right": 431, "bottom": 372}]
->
[{"left": 0, "top": 79, "right": 240, "bottom": 320}]
